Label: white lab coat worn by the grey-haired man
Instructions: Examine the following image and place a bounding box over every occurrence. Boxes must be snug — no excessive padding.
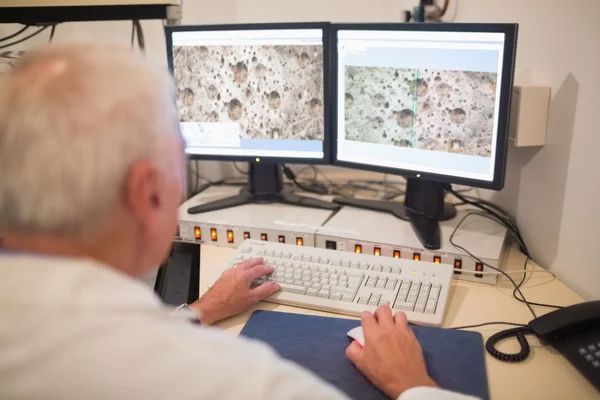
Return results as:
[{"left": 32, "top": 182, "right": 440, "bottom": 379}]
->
[{"left": 0, "top": 250, "right": 468, "bottom": 400}]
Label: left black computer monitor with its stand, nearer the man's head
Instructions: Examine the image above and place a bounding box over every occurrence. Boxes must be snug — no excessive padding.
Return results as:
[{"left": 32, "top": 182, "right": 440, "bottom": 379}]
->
[{"left": 165, "top": 23, "right": 339, "bottom": 213}]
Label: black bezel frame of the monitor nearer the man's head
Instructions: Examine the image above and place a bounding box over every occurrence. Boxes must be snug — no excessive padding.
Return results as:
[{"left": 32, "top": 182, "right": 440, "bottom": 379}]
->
[{"left": 165, "top": 22, "right": 332, "bottom": 165}]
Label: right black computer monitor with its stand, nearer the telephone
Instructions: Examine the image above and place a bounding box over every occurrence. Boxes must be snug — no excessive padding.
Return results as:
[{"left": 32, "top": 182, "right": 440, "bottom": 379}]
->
[{"left": 332, "top": 23, "right": 517, "bottom": 249}]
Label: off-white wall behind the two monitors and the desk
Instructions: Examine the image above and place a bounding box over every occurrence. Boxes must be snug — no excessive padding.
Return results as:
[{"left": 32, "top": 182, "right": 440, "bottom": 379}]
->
[{"left": 0, "top": 0, "right": 600, "bottom": 299}]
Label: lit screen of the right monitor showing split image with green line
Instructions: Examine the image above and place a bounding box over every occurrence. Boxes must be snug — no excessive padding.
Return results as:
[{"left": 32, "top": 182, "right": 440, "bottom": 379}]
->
[{"left": 334, "top": 28, "right": 513, "bottom": 182}]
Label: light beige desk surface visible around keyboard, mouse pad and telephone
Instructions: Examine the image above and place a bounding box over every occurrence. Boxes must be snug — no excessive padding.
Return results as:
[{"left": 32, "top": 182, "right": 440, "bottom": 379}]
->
[{"left": 200, "top": 245, "right": 600, "bottom": 400}]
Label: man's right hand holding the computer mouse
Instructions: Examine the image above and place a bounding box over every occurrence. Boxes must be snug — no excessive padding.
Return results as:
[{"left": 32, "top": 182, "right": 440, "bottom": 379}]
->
[{"left": 346, "top": 306, "right": 437, "bottom": 399}]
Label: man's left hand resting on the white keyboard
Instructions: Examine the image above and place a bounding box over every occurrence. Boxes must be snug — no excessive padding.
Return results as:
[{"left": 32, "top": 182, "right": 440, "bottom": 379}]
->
[{"left": 190, "top": 258, "right": 280, "bottom": 325}]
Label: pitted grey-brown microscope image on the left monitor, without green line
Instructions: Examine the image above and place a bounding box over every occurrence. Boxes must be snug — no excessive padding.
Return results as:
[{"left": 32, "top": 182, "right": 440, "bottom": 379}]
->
[{"left": 173, "top": 45, "right": 324, "bottom": 140}]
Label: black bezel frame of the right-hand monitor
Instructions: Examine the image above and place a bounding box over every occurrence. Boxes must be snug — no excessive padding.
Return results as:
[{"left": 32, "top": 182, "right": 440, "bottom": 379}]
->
[{"left": 330, "top": 23, "right": 518, "bottom": 190}]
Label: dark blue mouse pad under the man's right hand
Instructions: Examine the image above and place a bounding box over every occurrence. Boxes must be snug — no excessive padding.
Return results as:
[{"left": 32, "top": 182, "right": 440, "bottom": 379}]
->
[{"left": 241, "top": 310, "right": 489, "bottom": 400}]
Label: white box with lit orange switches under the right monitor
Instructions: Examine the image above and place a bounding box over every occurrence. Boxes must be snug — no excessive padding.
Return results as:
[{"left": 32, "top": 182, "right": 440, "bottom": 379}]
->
[{"left": 316, "top": 207, "right": 510, "bottom": 285}]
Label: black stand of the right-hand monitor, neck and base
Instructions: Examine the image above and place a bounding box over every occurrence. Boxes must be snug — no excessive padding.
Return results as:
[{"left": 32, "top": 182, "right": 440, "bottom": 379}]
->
[{"left": 333, "top": 178, "right": 456, "bottom": 250}]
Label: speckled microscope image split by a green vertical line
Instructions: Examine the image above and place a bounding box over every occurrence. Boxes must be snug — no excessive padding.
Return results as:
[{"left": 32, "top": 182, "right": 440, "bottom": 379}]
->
[{"left": 345, "top": 66, "right": 497, "bottom": 157}]
